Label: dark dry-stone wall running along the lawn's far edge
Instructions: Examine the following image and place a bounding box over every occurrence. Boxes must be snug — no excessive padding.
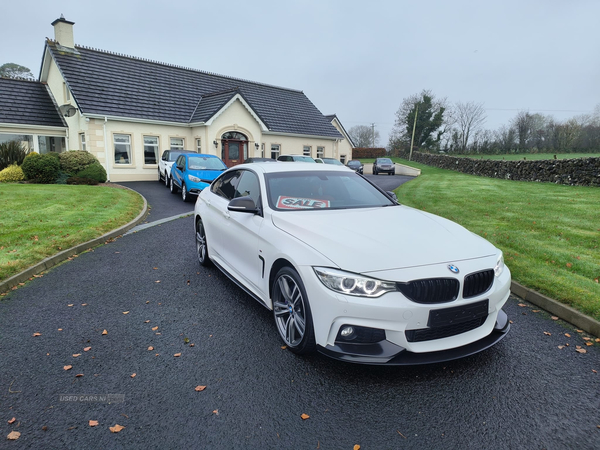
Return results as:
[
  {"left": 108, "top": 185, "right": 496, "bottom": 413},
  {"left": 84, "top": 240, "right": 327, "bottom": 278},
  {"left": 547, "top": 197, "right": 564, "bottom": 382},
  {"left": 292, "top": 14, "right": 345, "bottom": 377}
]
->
[{"left": 401, "top": 152, "right": 600, "bottom": 187}]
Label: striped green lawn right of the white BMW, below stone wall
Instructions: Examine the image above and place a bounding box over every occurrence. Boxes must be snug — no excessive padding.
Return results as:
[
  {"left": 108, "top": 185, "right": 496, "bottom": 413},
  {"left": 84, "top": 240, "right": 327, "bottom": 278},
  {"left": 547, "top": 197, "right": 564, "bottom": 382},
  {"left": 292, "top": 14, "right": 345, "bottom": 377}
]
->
[{"left": 395, "top": 159, "right": 600, "bottom": 320}]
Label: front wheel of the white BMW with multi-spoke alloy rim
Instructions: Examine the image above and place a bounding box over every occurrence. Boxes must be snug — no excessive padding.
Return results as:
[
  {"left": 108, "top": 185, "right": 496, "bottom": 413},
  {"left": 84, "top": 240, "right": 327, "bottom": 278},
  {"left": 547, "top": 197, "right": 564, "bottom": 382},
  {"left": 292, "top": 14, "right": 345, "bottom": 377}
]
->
[{"left": 272, "top": 267, "right": 317, "bottom": 355}]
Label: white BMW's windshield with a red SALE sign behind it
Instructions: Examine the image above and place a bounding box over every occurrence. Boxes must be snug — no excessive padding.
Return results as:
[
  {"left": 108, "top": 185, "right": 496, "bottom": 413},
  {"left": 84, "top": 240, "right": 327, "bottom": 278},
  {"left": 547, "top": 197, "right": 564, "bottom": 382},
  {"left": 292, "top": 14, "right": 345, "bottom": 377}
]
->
[{"left": 265, "top": 171, "right": 396, "bottom": 211}]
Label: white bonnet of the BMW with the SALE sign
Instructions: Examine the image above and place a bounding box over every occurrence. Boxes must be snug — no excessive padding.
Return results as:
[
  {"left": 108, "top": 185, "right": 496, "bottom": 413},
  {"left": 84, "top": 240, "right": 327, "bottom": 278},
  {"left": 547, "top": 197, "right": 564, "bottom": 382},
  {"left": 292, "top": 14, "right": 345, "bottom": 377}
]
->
[{"left": 272, "top": 206, "right": 497, "bottom": 273}]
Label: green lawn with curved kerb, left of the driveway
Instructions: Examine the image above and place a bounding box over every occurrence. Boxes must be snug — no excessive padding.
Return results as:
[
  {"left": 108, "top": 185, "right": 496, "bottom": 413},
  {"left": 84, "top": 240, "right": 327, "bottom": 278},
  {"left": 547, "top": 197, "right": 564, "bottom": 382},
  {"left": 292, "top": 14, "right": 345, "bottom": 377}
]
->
[{"left": 0, "top": 183, "right": 144, "bottom": 280}]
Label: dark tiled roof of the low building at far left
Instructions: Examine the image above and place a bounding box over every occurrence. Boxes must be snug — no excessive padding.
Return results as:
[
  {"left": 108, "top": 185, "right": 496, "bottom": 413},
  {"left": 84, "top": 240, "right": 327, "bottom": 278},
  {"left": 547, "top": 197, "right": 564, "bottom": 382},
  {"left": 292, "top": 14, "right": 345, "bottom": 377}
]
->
[{"left": 0, "top": 78, "right": 66, "bottom": 127}]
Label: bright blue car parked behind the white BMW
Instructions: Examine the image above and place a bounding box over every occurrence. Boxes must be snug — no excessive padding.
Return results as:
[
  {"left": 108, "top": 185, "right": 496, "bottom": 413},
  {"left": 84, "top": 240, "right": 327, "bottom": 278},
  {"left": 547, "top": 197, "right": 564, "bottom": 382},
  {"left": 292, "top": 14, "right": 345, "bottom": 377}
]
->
[{"left": 169, "top": 153, "right": 227, "bottom": 202}]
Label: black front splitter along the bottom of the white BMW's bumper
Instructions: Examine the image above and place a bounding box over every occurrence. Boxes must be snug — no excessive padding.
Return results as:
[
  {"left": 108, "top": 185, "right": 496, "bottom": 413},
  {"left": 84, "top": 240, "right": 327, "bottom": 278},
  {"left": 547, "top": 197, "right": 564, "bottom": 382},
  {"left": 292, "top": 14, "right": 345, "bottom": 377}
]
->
[{"left": 318, "top": 310, "right": 510, "bottom": 366}]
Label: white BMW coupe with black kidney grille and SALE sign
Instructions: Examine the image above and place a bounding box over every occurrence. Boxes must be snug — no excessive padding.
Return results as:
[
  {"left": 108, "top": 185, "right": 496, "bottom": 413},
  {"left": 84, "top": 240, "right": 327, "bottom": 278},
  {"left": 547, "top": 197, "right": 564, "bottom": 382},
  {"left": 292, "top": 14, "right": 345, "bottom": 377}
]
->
[{"left": 194, "top": 163, "right": 511, "bottom": 365}]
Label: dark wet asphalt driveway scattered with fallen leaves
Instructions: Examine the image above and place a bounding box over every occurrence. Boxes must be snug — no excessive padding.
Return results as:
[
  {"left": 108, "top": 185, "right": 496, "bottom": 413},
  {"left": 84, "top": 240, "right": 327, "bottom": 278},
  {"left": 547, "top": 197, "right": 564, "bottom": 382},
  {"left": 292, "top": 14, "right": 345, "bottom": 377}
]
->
[{"left": 0, "top": 176, "right": 600, "bottom": 450}]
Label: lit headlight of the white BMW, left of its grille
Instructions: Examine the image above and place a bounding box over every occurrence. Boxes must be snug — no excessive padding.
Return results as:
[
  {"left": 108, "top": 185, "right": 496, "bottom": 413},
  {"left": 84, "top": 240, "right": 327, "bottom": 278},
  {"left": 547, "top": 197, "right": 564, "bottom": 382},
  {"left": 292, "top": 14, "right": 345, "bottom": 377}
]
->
[{"left": 313, "top": 267, "right": 396, "bottom": 297}]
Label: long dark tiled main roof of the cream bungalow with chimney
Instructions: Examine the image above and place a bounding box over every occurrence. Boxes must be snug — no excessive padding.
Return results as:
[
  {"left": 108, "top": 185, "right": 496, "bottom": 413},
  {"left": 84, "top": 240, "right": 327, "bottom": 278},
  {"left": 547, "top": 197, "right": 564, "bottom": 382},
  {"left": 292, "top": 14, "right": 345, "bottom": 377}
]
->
[{"left": 47, "top": 40, "right": 343, "bottom": 138}]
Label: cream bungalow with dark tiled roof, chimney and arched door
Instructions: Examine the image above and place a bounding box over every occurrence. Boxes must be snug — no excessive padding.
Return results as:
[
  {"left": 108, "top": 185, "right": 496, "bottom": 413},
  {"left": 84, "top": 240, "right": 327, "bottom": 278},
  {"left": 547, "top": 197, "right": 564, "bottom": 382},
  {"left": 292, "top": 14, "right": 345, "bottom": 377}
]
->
[{"left": 5, "top": 17, "right": 352, "bottom": 182}]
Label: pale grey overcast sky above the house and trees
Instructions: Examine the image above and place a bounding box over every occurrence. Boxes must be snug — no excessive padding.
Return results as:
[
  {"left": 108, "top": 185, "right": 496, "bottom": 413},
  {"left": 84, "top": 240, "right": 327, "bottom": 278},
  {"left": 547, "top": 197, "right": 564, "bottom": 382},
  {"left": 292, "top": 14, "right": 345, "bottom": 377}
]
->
[{"left": 0, "top": 0, "right": 600, "bottom": 145}]
